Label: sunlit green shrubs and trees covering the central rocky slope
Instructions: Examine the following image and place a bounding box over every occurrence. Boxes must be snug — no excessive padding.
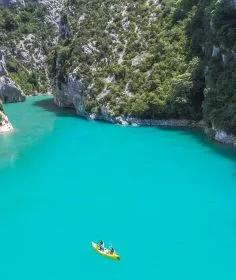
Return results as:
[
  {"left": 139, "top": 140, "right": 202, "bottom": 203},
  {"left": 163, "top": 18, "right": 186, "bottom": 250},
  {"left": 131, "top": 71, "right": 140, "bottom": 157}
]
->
[{"left": 51, "top": 0, "right": 204, "bottom": 119}]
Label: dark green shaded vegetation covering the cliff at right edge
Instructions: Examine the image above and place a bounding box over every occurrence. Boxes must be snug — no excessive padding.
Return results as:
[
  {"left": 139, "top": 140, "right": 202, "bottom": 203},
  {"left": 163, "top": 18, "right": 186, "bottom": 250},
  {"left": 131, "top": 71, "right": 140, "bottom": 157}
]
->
[{"left": 200, "top": 0, "right": 236, "bottom": 134}]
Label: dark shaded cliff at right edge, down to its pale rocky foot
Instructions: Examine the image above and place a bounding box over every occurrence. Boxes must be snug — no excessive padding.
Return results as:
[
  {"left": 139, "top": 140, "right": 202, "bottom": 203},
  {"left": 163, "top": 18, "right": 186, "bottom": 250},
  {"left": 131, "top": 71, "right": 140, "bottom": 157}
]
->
[{"left": 199, "top": 0, "right": 236, "bottom": 145}]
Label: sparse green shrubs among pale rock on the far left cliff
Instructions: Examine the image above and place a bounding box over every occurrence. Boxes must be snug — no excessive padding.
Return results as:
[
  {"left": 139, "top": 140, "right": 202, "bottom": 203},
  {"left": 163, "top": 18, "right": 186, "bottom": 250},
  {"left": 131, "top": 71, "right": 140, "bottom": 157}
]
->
[{"left": 0, "top": 4, "right": 56, "bottom": 94}]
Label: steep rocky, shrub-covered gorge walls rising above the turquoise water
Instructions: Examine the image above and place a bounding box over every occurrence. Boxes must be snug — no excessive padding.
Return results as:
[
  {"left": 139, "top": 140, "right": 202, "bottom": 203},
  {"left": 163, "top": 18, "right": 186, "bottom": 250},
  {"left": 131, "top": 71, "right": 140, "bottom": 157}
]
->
[{"left": 0, "top": 0, "right": 236, "bottom": 145}]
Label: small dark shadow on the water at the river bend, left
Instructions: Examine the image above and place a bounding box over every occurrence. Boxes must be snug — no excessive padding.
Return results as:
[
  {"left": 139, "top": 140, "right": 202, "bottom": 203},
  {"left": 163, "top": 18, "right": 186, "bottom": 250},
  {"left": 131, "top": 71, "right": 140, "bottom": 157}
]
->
[{"left": 33, "top": 98, "right": 78, "bottom": 117}]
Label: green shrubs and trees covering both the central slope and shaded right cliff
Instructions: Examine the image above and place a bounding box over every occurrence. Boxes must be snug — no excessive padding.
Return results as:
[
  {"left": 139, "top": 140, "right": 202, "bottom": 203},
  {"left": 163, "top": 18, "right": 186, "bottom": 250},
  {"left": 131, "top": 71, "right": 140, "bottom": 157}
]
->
[{"left": 49, "top": 0, "right": 236, "bottom": 133}]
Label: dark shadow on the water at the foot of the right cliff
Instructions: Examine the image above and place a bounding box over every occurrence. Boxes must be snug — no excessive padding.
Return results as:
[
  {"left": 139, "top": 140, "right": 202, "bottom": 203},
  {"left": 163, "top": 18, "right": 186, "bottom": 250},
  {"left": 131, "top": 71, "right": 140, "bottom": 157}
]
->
[{"left": 158, "top": 127, "right": 236, "bottom": 168}]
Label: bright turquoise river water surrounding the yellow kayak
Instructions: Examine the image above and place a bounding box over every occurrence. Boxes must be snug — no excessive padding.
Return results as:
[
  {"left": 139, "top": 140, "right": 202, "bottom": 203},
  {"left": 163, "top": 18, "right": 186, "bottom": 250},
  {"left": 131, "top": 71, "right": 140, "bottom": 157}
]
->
[{"left": 0, "top": 97, "right": 236, "bottom": 280}]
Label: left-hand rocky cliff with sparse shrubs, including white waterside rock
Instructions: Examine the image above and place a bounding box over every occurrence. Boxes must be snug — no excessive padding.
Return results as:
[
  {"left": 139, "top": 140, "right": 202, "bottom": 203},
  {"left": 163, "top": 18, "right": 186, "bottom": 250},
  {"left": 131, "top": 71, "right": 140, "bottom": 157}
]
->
[{"left": 0, "top": 0, "right": 61, "bottom": 132}]
